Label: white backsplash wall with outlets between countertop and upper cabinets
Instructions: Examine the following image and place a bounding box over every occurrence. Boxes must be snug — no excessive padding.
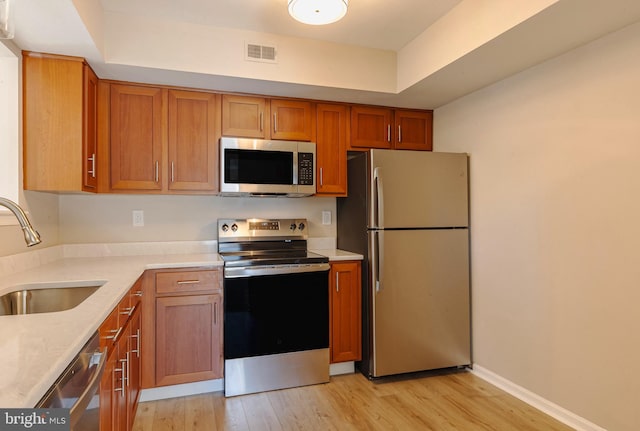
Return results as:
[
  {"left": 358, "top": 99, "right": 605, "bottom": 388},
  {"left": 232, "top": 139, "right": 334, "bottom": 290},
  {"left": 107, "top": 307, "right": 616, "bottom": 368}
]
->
[{"left": 59, "top": 195, "right": 336, "bottom": 244}]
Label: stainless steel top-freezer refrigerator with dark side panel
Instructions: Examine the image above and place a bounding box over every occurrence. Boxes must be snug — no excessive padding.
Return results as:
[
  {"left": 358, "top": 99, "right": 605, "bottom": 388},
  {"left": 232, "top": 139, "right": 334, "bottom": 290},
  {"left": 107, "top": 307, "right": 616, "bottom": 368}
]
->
[{"left": 337, "top": 150, "right": 471, "bottom": 377}]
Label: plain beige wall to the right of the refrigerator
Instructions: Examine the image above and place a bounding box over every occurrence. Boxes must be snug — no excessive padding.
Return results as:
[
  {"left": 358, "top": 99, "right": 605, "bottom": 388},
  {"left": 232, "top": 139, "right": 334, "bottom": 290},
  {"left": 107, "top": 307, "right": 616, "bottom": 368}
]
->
[{"left": 434, "top": 23, "right": 640, "bottom": 431}]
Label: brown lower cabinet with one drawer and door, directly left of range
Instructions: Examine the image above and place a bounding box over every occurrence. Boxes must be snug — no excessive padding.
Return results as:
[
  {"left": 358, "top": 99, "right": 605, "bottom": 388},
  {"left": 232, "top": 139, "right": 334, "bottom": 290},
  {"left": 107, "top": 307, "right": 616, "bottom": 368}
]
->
[{"left": 142, "top": 268, "right": 223, "bottom": 388}]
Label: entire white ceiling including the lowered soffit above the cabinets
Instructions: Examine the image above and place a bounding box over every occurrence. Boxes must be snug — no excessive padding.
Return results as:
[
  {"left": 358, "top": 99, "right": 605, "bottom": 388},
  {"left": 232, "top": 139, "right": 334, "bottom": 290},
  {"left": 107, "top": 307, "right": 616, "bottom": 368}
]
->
[{"left": 14, "top": 0, "right": 640, "bottom": 109}]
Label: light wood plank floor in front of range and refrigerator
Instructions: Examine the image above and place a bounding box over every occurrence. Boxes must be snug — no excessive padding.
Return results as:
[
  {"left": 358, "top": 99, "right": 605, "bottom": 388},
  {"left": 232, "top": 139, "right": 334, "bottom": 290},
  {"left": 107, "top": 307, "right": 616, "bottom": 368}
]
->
[{"left": 134, "top": 372, "right": 571, "bottom": 431}]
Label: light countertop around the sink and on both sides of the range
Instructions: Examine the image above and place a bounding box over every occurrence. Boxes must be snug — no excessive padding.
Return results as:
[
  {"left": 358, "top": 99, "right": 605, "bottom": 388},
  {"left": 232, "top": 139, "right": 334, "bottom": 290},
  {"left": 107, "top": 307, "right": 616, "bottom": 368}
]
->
[{"left": 0, "top": 249, "right": 362, "bottom": 408}]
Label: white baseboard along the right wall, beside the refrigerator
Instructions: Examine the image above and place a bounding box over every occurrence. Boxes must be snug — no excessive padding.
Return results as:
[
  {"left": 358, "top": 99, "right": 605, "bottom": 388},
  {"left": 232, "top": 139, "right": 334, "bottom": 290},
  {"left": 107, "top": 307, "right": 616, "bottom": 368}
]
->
[{"left": 472, "top": 365, "right": 607, "bottom": 431}]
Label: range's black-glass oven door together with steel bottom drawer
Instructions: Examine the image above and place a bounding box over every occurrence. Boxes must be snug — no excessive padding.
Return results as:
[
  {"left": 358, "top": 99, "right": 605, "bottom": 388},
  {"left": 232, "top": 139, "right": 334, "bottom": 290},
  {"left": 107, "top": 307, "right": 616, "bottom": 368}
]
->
[{"left": 224, "top": 263, "right": 329, "bottom": 396}]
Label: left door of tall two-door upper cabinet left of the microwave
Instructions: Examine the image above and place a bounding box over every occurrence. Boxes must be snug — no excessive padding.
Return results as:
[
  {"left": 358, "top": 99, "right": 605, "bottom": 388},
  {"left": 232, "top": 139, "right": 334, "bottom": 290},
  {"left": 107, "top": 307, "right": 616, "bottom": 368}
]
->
[{"left": 110, "top": 84, "right": 163, "bottom": 190}]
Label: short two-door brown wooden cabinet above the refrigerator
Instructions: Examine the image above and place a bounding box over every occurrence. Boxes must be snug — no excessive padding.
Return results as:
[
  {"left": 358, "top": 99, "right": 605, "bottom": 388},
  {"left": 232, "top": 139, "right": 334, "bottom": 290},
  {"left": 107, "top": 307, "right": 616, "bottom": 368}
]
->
[{"left": 350, "top": 106, "right": 433, "bottom": 151}]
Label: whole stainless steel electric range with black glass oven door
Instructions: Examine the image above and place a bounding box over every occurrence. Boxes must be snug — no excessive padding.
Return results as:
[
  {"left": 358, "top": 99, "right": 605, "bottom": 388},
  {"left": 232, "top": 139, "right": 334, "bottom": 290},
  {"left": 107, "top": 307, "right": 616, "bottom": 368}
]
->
[{"left": 218, "top": 219, "right": 329, "bottom": 396}]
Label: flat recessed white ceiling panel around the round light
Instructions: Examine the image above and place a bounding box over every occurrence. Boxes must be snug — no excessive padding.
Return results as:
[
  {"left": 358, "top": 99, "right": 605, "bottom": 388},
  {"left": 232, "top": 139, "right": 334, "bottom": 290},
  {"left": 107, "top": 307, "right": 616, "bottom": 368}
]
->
[{"left": 100, "top": 0, "right": 461, "bottom": 51}]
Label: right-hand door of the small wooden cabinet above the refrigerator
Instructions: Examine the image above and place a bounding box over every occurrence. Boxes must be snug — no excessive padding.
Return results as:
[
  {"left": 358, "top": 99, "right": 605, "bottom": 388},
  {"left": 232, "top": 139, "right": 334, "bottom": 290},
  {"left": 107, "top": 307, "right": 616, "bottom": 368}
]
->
[{"left": 394, "top": 110, "right": 433, "bottom": 151}]
